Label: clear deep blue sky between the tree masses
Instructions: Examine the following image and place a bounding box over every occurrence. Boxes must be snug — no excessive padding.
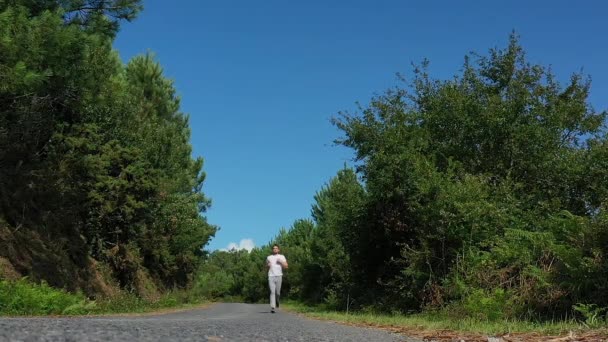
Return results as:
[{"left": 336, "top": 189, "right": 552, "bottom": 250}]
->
[{"left": 115, "top": 0, "right": 608, "bottom": 250}]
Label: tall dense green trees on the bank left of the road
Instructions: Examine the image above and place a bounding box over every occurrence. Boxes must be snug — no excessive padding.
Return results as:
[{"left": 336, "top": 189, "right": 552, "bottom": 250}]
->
[{"left": 0, "top": 0, "right": 216, "bottom": 296}]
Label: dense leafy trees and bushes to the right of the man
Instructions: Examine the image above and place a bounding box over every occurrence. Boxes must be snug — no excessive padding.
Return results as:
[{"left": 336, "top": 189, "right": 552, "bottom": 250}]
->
[{"left": 202, "top": 35, "right": 608, "bottom": 319}]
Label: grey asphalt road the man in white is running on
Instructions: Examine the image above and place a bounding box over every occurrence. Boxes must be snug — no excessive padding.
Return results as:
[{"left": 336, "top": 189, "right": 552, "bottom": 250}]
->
[{"left": 0, "top": 303, "right": 418, "bottom": 342}]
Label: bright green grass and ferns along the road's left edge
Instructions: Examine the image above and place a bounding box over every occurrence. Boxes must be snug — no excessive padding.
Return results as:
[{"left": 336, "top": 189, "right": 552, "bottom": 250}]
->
[{"left": 0, "top": 278, "right": 208, "bottom": 316}]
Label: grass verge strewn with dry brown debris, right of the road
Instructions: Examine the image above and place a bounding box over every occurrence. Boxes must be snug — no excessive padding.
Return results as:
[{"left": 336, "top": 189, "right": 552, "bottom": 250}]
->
[{"left": 284, "top": 302, "right": 608, "bottom": 338}]
